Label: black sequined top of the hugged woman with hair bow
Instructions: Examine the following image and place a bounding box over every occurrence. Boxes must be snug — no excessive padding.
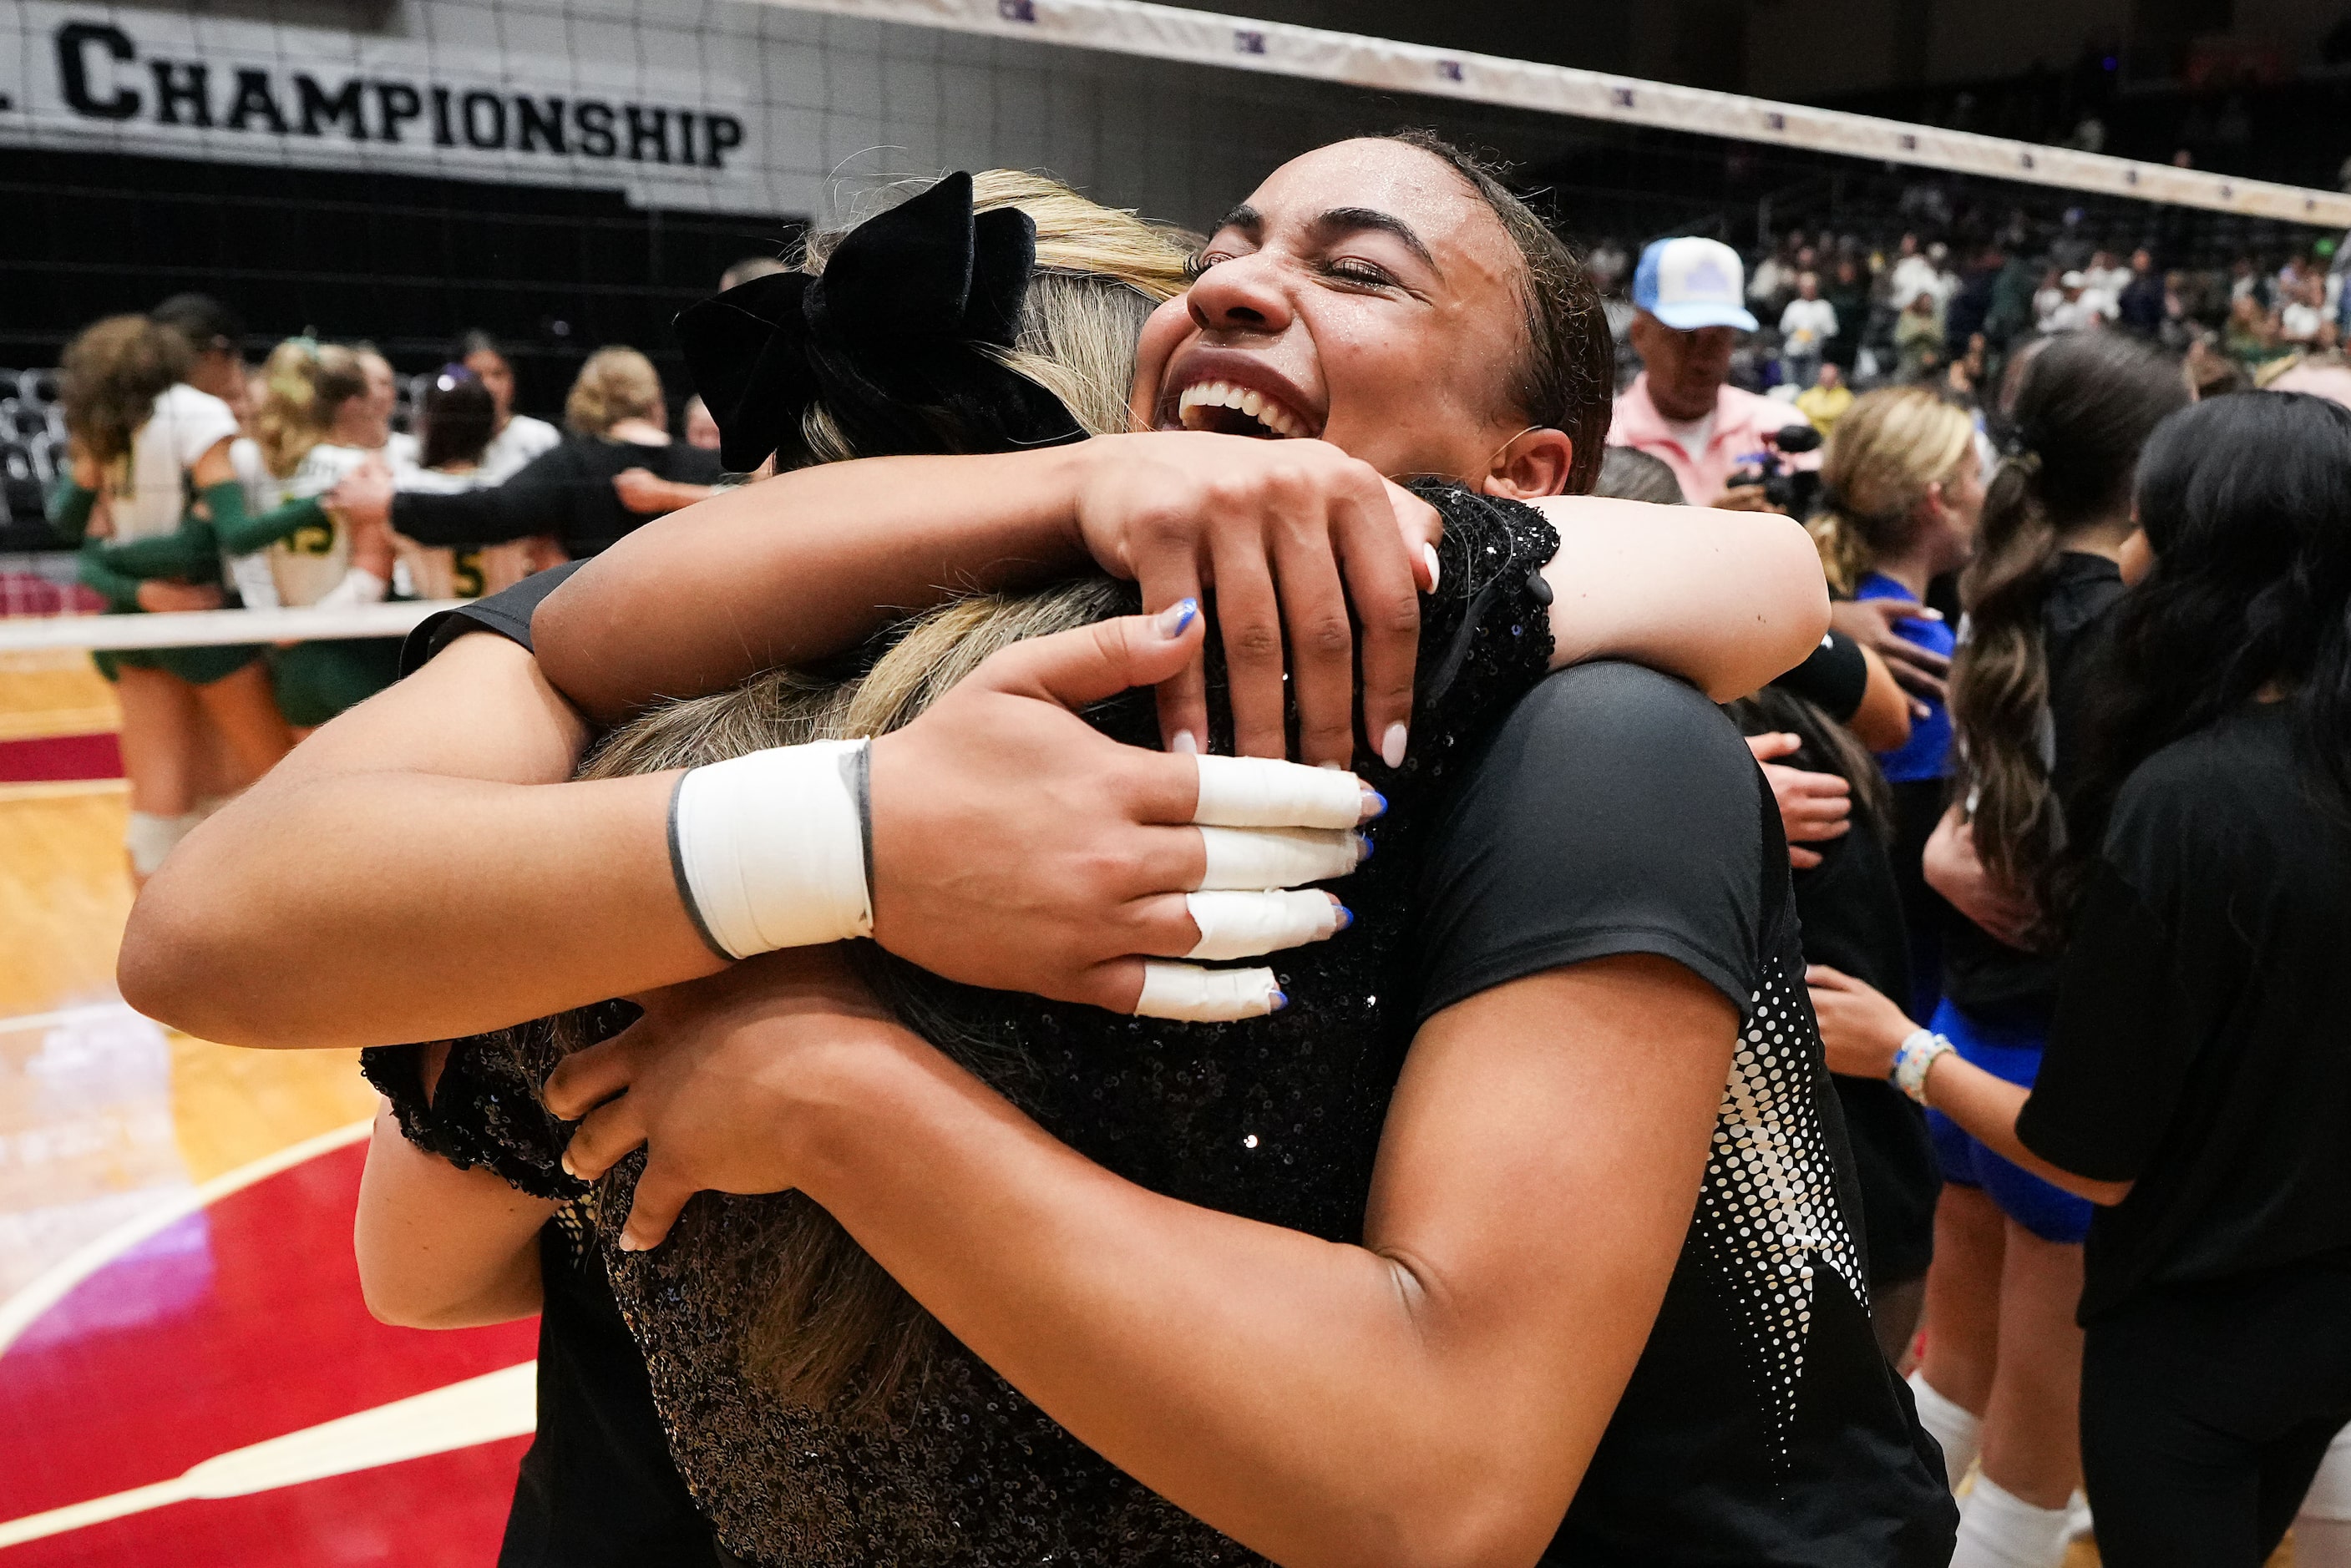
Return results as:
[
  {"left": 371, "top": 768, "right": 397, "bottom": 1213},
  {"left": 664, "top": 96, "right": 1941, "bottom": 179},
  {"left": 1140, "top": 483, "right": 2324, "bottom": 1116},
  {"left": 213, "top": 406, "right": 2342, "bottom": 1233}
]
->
[{"left": 369, "top": 489, "right": 1558, "bottom": 1568}]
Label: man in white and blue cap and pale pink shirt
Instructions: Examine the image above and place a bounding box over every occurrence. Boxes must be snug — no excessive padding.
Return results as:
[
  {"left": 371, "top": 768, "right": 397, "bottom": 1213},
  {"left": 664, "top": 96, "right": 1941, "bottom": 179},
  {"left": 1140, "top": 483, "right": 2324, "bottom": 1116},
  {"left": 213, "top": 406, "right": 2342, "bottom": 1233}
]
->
[{"left": 1608, "top": 235, "right": 1820, "bottom": 513}]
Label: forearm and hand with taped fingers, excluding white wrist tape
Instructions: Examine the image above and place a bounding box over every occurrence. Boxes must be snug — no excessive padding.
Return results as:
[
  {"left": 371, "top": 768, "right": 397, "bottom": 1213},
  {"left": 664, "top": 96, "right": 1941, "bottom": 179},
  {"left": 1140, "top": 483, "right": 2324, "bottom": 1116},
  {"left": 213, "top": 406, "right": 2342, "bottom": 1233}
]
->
[{"left": 118, "top": 611, "right": 1364, "bottom": 1046}]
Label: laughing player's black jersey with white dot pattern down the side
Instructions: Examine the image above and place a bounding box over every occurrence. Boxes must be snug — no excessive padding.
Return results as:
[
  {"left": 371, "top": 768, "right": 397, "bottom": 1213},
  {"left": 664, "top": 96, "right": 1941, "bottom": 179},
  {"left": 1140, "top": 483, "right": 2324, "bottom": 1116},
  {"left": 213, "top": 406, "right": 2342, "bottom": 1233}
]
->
[{"left": 1422, "top": 663, "right": 1956, "bottom": 1568}]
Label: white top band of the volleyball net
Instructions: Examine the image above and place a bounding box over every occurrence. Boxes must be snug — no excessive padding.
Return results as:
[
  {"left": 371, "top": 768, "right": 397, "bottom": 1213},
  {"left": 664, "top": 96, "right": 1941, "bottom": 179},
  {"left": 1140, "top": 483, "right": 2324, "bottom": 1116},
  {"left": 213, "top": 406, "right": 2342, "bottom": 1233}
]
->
[{"left": 759, "top": 0, "right": 2351, "bottom": 228}]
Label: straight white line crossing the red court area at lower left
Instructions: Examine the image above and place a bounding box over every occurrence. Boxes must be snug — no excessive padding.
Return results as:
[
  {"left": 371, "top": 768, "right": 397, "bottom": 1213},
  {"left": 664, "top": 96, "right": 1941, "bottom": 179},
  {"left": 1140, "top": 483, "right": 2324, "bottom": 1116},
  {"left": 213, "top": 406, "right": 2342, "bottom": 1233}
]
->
[{"left": 0, "top": 1361, "right": 539, "bottom": 1549}]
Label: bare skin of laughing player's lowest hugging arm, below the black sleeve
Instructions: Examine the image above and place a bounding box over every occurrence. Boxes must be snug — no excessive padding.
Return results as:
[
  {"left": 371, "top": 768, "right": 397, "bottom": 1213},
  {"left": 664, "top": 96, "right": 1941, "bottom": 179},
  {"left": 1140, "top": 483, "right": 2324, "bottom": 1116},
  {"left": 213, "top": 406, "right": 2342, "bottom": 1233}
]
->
[{"left": 548, "top": 954, "right": 1737, "bottom": 1568}]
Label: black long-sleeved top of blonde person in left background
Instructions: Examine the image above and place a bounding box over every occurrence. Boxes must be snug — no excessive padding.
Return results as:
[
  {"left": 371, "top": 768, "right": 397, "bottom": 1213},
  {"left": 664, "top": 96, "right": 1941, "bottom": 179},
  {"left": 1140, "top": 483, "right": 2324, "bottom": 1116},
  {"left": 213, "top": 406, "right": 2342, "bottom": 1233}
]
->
[{"left": 393, "top": 435, "right": 724, "bottom": 559}]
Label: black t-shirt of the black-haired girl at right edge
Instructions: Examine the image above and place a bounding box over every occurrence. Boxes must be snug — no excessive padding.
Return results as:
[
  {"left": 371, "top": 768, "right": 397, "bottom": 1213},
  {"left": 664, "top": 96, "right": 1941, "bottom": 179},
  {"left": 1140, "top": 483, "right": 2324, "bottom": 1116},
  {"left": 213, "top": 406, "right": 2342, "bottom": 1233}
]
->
[{"left": 2017, "top": 703, "right": 2351, "bottom": 1321}]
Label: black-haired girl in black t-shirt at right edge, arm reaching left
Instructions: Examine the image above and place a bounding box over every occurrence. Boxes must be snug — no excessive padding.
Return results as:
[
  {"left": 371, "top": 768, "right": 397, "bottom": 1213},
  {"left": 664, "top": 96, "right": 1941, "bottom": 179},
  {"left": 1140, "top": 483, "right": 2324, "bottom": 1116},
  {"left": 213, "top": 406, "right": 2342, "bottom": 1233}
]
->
[{"left": 1815, "top": 392, "right": 2351, "bottom": 1568}]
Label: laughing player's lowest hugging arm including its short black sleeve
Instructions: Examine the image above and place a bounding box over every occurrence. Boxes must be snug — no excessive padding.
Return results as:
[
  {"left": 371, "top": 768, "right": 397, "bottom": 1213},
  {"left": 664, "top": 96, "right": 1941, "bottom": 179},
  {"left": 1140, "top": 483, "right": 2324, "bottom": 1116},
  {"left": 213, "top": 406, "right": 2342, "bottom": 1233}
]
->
[{"left": 548, "top": 665, "right": 1761, "bottom": 1568}]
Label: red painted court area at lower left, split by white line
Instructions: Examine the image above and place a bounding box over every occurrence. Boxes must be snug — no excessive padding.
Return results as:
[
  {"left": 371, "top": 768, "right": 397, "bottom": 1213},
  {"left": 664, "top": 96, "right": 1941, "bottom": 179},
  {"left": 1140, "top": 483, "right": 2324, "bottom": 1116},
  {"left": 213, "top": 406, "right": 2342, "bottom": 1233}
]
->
[{"left": 0, "top": 1142, "right": 539, "bottom": 1568}]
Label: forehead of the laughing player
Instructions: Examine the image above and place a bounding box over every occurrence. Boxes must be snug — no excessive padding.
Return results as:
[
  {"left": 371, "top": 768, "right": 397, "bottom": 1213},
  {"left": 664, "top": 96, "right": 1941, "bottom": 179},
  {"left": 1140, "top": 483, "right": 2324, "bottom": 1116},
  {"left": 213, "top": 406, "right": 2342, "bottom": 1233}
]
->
[{"left": 1249, "top": 136, "right": 1512, "bottom": 273}]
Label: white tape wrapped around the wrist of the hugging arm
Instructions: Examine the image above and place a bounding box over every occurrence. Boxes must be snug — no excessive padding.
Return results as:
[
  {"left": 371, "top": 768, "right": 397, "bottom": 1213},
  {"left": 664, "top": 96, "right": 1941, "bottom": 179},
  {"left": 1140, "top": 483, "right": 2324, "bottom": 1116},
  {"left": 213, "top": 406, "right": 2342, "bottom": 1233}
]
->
[{"left": 670, "top": 741, "right": 874, "bottom": 959}]
